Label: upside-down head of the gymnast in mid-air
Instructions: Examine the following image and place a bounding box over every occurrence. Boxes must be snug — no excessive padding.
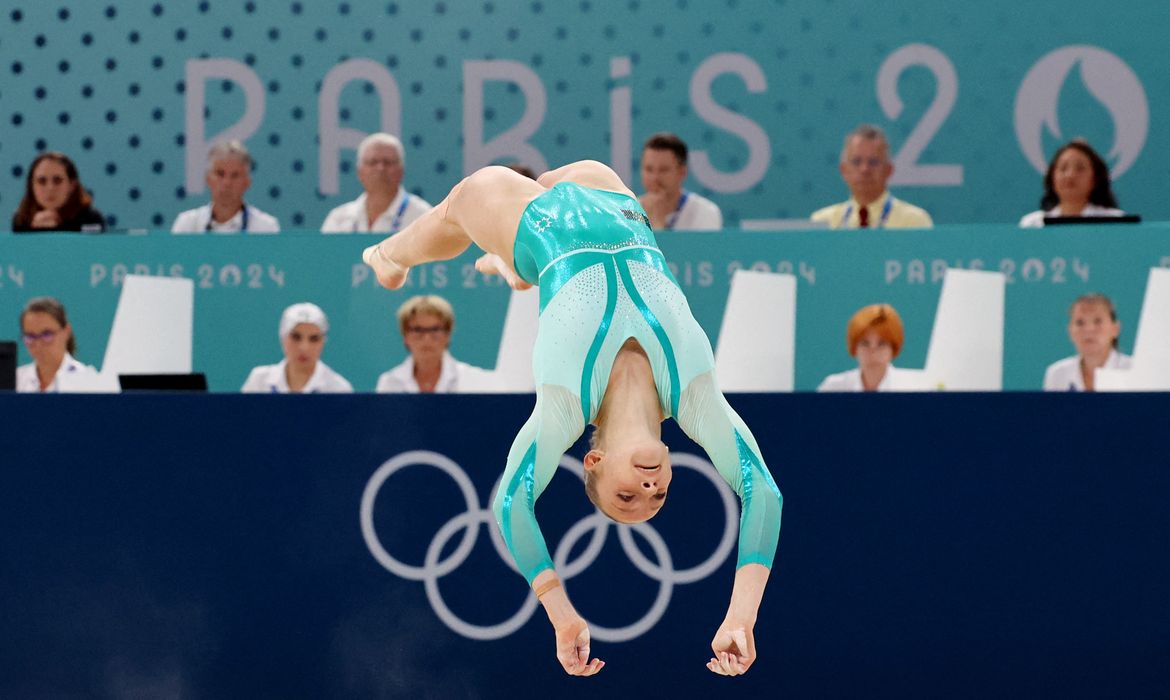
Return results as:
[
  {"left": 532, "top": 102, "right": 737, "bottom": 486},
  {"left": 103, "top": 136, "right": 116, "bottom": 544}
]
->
[{"left": 585, "top": 440, "right": 673, "bottom": 523}]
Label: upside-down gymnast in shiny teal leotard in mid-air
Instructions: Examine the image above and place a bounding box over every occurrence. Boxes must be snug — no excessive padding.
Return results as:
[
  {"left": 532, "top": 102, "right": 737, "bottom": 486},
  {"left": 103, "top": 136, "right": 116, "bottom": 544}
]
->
[{"left": 363, "top": 160, "right": 783, "bottom": 675}]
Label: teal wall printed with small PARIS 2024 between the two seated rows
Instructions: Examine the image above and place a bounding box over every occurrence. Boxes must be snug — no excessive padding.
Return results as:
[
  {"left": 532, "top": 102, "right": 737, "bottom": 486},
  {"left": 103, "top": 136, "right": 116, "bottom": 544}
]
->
[{"left": 0, "top": 224, "right": 1170, "bottom": 391}]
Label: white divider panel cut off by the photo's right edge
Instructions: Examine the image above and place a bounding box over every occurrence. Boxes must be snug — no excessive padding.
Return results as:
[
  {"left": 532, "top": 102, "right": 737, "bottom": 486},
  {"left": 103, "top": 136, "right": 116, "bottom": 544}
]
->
[{"left": 1095, "top": 267, "right": 1170, "bottom": 391}]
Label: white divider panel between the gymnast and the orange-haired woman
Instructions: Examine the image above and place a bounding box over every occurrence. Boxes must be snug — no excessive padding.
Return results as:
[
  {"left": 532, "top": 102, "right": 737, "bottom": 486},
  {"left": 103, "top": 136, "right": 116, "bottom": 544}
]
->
[{"left": 715, "top": 269, "right": 797, "bottom": 392}]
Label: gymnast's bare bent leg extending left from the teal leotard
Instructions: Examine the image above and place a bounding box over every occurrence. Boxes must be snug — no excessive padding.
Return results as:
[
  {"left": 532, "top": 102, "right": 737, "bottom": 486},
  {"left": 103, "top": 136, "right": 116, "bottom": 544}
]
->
[{"left": 362, "top": 166, "right": 545, "bottom": 289}]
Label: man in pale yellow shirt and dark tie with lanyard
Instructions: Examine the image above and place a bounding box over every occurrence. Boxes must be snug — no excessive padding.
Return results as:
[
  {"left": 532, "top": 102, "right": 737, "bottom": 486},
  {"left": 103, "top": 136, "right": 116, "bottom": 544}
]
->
[{"left": 810, "top": 124, "right": 934, "bottom": 228}]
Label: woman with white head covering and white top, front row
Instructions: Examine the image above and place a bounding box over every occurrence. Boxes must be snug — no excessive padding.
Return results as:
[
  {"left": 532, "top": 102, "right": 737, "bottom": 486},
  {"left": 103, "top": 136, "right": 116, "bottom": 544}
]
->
[{"left": 240, "top": 302, "right": 353, "bottom": 393}]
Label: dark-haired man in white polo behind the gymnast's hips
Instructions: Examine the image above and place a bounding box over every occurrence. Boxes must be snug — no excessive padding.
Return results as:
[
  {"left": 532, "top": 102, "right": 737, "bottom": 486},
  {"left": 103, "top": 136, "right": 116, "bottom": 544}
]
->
[{"left": 638, "top": 131, "right": 723, "bottom": 231}]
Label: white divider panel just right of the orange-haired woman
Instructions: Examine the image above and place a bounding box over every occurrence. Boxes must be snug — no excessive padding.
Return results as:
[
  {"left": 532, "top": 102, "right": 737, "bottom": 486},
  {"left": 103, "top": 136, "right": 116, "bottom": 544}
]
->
[{"left": 924, "top": 269, "right": 1006, "bottom": 391}]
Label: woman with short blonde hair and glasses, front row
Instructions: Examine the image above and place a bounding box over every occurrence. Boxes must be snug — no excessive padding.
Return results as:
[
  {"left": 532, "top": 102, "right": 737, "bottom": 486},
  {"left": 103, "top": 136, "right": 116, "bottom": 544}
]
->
[{"left": 374, "top": 294, "right": 487, "bottom": 393}]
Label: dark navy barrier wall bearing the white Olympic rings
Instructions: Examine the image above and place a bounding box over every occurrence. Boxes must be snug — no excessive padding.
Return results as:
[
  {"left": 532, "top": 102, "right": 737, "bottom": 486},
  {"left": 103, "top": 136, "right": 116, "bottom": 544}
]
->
[{"left": 0, "top": 394, "right": 1170, "bottom": 699}]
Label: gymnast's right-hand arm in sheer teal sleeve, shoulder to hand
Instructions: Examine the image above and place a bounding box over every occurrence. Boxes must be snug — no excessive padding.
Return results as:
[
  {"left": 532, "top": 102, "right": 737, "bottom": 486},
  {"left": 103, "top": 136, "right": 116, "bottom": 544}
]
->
[{"left": 675, "top": 372, "right": 784, "bottom": 675}]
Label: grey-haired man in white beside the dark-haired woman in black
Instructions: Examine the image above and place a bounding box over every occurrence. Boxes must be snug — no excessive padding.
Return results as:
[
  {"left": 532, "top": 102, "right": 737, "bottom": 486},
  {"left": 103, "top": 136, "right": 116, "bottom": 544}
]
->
[{"left": 171, "top": 140, "right": 281, "bottom": 233}]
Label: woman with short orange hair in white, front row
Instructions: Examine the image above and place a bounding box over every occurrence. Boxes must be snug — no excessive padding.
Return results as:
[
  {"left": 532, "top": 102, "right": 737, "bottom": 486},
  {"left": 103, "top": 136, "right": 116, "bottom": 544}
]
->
[{"left": 817, "top": 304, "right": 906, "bottom": 391}]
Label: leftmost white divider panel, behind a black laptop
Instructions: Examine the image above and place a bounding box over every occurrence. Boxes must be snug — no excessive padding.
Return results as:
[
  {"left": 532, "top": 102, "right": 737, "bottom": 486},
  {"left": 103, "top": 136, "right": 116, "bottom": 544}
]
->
[{"left": 102, "top": 275, "right": 195, "bottom": 376}]
